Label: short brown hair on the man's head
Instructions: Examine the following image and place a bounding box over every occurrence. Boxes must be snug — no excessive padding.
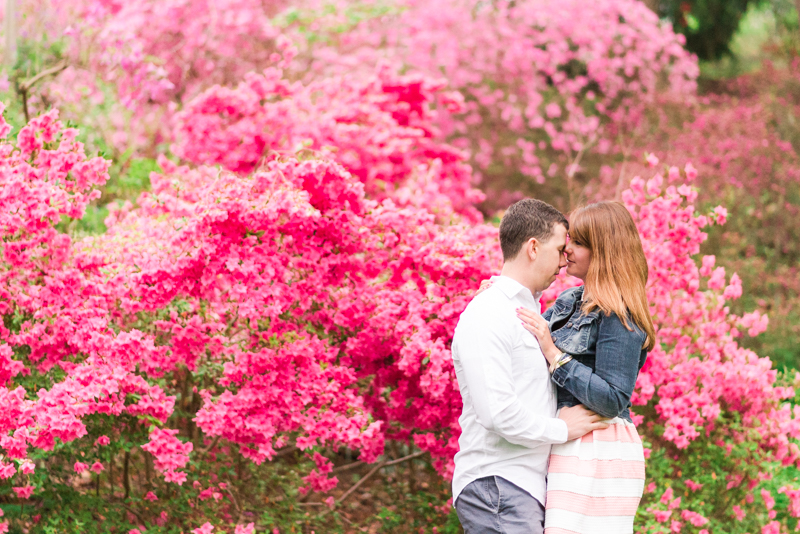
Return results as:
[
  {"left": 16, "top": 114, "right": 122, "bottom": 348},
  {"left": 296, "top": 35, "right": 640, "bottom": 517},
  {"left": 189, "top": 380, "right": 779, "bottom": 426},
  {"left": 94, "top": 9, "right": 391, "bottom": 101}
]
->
[{"left": 500, "top": 198, "right": 569, "bottom": 261}]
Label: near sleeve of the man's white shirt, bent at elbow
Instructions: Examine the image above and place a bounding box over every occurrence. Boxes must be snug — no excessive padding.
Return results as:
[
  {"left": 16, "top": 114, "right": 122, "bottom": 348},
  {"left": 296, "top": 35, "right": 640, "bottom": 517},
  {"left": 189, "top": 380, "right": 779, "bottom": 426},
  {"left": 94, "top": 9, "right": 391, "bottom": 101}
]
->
[{"left": 455, "top": 312, "right": 568, "bottom": 448}]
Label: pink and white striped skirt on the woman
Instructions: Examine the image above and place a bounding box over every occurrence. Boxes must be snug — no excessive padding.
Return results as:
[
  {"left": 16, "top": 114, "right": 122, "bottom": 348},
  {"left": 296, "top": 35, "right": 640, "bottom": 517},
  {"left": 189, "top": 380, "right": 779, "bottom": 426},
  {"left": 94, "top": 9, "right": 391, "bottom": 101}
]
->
[{"left": 544, "top": 417, "right": 644, "bottom": 534}]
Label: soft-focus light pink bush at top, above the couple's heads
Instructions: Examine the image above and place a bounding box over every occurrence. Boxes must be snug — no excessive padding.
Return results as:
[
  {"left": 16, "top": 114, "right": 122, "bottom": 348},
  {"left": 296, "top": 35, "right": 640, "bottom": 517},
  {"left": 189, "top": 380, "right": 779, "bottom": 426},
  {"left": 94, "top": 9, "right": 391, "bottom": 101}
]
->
[{"left": 277, "top": 0, "right": 698, "bottom": 209}]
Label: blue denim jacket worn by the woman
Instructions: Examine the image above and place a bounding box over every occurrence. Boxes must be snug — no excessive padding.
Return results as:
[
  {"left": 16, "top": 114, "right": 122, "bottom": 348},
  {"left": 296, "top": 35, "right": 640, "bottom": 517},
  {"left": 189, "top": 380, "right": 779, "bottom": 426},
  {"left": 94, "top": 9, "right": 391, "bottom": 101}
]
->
[{"left": 542, "top": 286, "right": 647, "bottom": 421}]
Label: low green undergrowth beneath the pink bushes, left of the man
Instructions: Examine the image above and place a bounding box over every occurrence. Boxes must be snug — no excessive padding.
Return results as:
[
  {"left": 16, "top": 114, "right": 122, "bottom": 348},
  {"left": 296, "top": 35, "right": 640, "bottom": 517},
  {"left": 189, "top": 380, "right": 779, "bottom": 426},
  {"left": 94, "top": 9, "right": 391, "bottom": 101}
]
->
[{"left": 0, "top": 450, "right": 461, "bottom": 534}]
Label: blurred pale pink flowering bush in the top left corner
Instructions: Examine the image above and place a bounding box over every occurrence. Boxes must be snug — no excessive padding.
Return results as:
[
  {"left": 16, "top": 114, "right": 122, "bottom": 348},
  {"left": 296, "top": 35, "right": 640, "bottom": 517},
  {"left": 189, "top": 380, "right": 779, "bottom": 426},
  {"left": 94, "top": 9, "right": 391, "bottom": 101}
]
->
[{"left": 0, "top": 0, "right": 293, "bottom": 157}]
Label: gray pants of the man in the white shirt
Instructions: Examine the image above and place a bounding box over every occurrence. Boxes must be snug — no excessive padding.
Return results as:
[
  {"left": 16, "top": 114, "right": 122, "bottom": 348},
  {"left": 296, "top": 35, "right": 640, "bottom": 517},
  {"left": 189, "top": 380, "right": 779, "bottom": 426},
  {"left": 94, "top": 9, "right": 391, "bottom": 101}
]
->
[{"left": 456, "top": 476, "right": 544, "bottom": 534}]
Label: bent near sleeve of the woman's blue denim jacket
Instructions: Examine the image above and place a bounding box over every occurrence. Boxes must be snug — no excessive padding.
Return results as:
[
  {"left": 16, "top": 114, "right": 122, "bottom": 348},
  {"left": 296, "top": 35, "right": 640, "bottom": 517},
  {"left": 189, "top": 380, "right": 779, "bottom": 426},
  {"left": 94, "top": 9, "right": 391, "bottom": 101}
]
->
[{"left": 552, "top": 315, "right": 645, "bottom": 417}]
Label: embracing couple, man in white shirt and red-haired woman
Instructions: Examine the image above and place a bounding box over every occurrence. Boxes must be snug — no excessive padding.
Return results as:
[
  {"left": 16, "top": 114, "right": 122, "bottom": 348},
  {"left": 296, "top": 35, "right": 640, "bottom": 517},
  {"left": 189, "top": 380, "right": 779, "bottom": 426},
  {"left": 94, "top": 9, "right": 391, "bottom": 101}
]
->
[{"left": 452, "top": 199, "right": 655, "bottom": 534}]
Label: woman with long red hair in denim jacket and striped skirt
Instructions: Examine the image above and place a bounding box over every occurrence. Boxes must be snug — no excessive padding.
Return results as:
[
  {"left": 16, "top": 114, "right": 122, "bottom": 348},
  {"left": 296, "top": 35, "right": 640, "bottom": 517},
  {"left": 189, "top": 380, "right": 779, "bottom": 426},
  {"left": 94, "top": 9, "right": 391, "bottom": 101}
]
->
[{"left": 478, "top": 202, "right": 655, "bottom": 534}]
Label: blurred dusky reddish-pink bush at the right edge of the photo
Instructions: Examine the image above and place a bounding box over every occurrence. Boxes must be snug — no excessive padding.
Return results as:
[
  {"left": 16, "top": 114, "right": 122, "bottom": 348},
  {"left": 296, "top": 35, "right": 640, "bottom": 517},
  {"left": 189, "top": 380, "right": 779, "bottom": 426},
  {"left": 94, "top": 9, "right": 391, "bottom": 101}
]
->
[{"left": 592, "top": 59, "right": 800, "bottom": 376}]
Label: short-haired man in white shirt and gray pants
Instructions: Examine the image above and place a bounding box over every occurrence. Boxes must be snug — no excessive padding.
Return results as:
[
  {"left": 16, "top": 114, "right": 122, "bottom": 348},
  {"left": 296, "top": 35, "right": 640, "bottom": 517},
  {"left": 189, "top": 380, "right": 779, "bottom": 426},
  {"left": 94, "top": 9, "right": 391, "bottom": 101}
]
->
[{"left": 453, "top": 199, "right": 608, "bottom": 534}]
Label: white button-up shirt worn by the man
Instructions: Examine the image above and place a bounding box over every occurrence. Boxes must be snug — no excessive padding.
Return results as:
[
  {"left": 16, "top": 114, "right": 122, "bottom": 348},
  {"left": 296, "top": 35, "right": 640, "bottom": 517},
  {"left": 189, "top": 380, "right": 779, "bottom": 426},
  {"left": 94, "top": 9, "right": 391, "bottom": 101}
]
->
[{"left": 453, "top": 276, "right": 567, "bottom": 504}]
